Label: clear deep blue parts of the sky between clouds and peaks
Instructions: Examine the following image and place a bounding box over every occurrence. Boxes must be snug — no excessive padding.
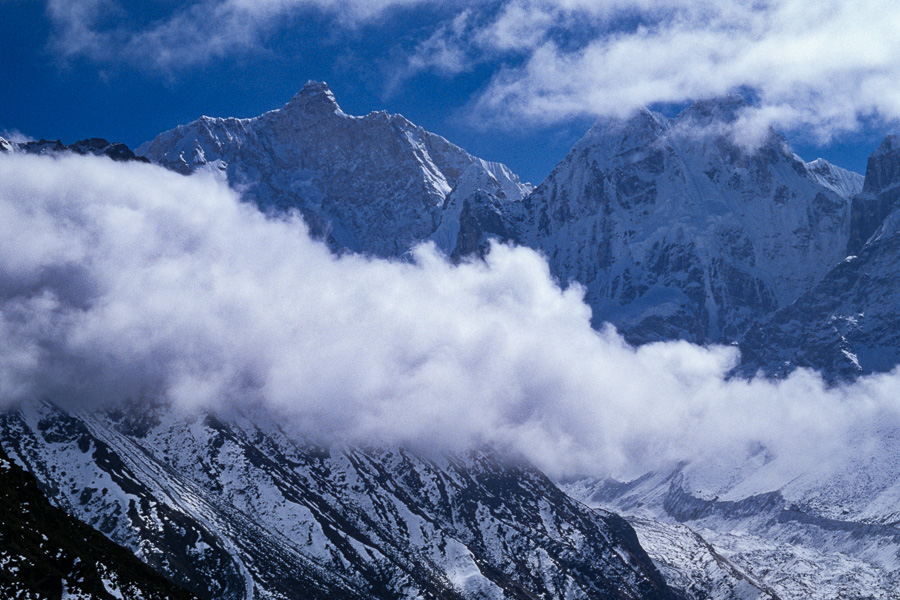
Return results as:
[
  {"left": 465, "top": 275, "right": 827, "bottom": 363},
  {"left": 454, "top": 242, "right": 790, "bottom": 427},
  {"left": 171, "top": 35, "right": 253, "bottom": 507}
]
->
[{"left": 0, "top": 0, "right": 885, "bottom": 183}]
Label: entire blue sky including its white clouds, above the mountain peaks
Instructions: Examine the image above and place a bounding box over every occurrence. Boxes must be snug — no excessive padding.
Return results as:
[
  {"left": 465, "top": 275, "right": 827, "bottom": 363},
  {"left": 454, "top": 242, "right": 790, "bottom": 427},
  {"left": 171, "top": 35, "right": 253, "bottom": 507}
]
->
[{"left": 0, "top": 0, "right": 900, "bottom": 182}]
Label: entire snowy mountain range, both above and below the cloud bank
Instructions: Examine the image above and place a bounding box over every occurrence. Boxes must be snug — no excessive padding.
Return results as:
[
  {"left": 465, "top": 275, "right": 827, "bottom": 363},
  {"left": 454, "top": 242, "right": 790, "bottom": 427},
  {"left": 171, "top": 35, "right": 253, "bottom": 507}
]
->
[{"left": 0, "top": 82, "right": 900, "bottom": 600}]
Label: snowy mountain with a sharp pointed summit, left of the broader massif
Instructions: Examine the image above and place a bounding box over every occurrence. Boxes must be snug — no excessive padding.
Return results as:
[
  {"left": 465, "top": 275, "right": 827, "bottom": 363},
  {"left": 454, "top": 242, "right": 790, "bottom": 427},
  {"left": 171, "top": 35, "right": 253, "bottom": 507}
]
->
[{"left": 137, "top": 82, "right": 531, "bottom": 256}]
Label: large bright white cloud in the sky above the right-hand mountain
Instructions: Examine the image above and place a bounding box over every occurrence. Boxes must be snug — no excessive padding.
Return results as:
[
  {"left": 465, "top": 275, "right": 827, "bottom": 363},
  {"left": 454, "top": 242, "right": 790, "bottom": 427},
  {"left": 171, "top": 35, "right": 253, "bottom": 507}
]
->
[{"left": 474, "top": 0, "right": 900, "bottom": 140}]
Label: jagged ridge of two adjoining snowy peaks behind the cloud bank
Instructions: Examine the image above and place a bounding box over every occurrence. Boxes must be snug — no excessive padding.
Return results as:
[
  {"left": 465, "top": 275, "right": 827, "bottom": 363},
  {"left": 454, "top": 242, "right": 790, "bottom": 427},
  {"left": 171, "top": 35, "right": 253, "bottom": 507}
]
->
[{"left": 138, "top": 88, "right": 862, "bottom": 343}]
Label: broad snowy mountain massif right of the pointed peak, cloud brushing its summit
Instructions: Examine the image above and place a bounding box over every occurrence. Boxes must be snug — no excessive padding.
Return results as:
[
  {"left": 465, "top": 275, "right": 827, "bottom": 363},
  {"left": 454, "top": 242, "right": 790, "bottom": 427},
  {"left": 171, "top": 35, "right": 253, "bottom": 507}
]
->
[{"left": 511, "top": 97, "right": 857, "bottom": 343}]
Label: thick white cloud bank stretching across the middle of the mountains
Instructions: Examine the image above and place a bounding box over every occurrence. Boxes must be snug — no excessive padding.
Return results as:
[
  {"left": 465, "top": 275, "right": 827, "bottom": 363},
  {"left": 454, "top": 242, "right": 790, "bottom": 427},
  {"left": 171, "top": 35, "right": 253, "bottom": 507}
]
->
[{"left": 0, "top": 155, "right": 900, "bottom": 476}]
